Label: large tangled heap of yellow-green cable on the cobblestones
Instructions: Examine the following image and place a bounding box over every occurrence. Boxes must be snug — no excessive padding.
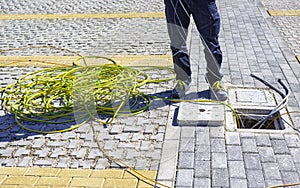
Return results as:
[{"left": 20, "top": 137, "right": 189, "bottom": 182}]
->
[{"left": 1, "top": 58, "right": 174, "bottom": 133}]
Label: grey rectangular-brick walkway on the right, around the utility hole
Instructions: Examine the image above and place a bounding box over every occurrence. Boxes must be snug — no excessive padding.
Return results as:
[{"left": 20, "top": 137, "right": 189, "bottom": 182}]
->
[{"left": 175, "top": 0, "right": 300, "bottom": 188}]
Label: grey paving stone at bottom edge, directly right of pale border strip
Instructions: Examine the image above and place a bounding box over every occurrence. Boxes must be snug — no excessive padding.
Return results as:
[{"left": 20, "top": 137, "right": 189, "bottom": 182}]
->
[{"left": 176, "top": 169, "right": 194, "bottom": 187}]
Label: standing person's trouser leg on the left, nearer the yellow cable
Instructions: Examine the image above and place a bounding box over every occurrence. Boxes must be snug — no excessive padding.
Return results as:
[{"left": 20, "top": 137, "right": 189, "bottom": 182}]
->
[{"left": 165, "top": 0, "right": 191, "bottom": 84}]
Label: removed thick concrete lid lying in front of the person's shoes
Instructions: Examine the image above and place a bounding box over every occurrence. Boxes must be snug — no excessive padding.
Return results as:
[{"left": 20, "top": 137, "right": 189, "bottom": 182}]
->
[{"left": 177, "top": 102, "right": 224, "bottom": 126}]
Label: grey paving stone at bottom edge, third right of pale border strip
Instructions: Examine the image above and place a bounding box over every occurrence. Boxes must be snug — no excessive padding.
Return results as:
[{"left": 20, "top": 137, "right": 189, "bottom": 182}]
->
[{"left": 212, "top": 168, "right": 229, "bottom": 187}]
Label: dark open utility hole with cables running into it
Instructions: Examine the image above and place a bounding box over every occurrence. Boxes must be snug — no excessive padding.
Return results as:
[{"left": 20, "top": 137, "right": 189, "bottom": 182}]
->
[{"left": 236, "top": 109, "right": 285, "bottom": 130}]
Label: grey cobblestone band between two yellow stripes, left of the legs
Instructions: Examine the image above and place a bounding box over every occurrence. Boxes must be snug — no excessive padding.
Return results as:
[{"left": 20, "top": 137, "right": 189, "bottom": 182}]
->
[{"left": 0, "top": 18, "right": 169, "bottom": 55}]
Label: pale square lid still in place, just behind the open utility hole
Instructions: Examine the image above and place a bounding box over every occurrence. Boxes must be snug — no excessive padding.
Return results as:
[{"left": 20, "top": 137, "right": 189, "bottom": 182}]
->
[{"left": 228, "top": 88, "right": 276, "bottom": 108}]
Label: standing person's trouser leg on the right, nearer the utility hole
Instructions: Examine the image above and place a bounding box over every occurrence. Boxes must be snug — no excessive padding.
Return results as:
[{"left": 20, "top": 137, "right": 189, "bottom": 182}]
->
[{"left": 191, "top": 0, "right": 223, "bottom": 85}]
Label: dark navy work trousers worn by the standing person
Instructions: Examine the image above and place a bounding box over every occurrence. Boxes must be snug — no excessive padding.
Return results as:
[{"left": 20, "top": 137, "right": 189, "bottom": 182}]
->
[{"left": 164, "top": 0, "right": 223, "bottom": 85}]
